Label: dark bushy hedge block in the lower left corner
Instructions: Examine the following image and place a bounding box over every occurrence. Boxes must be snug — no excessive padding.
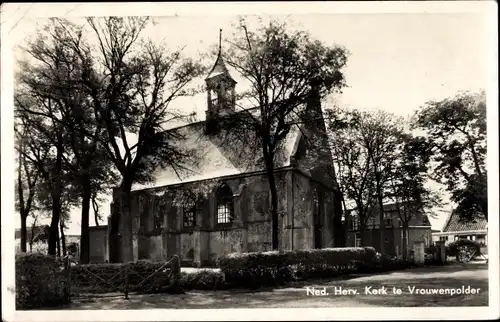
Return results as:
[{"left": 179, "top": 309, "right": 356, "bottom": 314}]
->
[{"left": 16, "top": 253, "right": 69, "bottom": 310}]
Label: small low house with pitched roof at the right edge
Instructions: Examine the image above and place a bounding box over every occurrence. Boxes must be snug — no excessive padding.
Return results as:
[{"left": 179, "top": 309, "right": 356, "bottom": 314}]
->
[{"left": 432, "top": 212, "right": 488, "bottom": 246}]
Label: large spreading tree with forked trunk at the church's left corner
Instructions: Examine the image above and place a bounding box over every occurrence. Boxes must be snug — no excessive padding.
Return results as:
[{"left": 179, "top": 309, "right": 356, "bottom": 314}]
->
[{"left": 54, "top": 17, "right": 203, "bottom": 261}]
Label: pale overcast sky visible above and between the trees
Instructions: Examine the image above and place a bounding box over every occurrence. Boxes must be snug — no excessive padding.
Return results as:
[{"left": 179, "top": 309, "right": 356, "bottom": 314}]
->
[{"left": 2, "top": 1, "right": 490, "bottom": 234}]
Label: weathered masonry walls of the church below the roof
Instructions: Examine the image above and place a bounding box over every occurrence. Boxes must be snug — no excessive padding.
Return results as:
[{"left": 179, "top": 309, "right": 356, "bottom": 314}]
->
[{"left": 122, "top": 171, "right": 333, "bottom": 265}]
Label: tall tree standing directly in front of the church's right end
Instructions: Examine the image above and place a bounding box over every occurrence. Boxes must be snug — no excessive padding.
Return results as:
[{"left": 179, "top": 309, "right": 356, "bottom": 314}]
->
[{"left": 223, "top": 19, "right": 347, "bottom": 249}]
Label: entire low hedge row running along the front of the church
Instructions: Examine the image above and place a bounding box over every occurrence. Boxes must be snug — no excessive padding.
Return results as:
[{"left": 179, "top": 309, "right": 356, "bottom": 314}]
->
[{"left": 66, "top": 247, "right": 446, "bottom": 293}]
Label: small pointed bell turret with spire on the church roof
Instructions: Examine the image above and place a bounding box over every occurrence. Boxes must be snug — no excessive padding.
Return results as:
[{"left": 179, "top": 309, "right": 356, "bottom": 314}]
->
[{"left": 205, "top": 29, "right": 236, "bottom": 133}]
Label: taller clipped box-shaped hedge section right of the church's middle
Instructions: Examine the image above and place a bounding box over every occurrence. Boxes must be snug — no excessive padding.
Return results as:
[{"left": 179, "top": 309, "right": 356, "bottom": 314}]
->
[{"left": 217, "top": 247, "right": 376, "bottom": 288}]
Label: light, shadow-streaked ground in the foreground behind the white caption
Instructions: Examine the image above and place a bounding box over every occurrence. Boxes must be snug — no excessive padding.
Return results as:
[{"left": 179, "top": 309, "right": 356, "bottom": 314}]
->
[{"left": 63, "top": 263, "right": 488, "bottom": 310}]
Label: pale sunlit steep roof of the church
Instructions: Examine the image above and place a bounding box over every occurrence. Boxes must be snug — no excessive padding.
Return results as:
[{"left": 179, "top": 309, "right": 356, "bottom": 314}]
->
[{"left": 132, "top": 110, "right": 302, "bottom": 190}]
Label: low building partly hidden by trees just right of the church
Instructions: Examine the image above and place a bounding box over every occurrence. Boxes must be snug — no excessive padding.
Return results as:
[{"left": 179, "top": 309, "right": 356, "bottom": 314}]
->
[{"left": 345, "top": 204, "right": 432, "bottom": 256}]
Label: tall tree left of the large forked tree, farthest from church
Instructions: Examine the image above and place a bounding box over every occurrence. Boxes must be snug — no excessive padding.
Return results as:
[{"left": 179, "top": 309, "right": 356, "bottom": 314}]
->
[{"left": 17, "top": 20, "right": 114, "bottom": 263}]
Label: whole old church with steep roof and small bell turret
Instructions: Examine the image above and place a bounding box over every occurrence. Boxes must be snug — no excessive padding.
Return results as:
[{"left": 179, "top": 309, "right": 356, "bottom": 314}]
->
[{"left": 108, "top": 36, "right": 336, "bottom": 266}]
